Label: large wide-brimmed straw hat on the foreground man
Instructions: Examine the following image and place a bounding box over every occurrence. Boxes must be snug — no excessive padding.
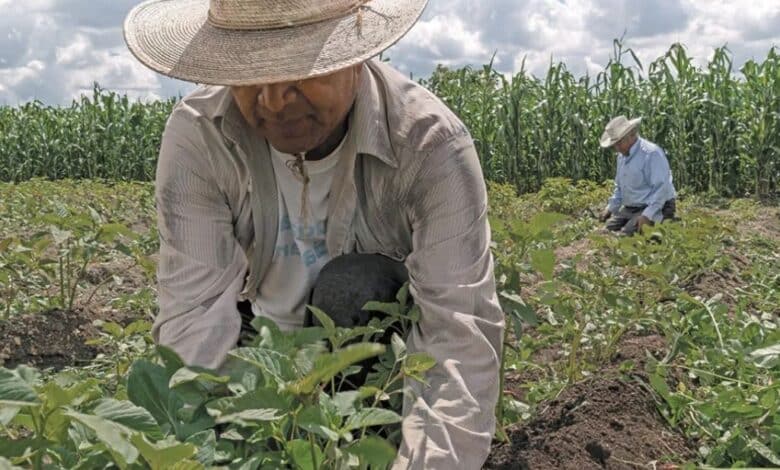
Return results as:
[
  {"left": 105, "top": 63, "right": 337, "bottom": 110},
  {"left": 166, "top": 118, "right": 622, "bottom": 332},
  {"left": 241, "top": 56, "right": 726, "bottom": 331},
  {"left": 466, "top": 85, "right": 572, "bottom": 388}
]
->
[{"left": 124, "top": 0, "right": 427, "bottom": 85}]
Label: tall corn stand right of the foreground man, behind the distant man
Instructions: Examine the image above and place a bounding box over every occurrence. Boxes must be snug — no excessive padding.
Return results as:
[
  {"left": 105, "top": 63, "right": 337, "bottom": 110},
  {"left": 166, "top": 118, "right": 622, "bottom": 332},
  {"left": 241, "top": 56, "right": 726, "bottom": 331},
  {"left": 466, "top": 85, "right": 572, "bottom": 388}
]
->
[{"left": 423, "top": 40, "right": 780, "bottom": 197}]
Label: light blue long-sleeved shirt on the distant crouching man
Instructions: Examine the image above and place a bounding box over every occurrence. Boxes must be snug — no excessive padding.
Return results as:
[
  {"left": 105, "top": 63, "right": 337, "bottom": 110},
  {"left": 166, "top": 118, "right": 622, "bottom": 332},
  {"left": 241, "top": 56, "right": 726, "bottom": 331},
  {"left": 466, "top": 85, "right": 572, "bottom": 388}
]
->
[{"left": 607, "top": 137, "right": 677, "bottom": 222}]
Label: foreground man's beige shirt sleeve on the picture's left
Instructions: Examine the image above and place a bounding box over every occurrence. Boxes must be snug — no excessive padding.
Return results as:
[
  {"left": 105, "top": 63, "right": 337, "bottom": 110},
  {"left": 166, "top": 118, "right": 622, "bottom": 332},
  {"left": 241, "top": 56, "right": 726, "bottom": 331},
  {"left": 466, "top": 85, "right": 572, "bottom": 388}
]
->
[{"left": 152, "top": 106, "right": 248, "bottom": 369}]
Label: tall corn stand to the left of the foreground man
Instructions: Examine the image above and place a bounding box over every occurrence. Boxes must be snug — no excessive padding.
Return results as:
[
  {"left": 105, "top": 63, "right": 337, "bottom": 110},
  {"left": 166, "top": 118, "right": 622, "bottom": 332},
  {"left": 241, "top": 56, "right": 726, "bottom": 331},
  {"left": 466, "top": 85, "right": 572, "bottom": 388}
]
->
[{"left": 0, "top": 85, "right": 175, "bottom": 182}]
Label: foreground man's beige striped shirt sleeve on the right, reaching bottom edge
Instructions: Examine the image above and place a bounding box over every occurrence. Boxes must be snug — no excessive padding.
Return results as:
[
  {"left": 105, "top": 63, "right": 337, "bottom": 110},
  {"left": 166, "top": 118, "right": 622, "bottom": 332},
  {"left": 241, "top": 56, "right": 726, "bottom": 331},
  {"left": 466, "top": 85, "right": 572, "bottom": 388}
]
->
[{"left": 393, "top": 134, "right": 504, "bottom": 470}]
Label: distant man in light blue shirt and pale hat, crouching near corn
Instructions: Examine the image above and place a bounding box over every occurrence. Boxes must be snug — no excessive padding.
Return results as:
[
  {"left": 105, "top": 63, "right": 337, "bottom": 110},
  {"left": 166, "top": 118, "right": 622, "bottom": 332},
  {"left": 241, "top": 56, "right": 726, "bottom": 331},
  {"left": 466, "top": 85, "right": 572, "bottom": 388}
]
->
[{"left": 600, "top": 116, "right": 676, "bottom": 235}]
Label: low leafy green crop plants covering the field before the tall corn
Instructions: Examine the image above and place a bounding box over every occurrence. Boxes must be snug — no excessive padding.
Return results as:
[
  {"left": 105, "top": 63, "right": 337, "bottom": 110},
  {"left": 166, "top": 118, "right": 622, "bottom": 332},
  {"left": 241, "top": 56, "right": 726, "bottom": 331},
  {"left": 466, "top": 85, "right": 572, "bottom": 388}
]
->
[{"left": 0, "top": 179, "right": 780, "bottom": 469}]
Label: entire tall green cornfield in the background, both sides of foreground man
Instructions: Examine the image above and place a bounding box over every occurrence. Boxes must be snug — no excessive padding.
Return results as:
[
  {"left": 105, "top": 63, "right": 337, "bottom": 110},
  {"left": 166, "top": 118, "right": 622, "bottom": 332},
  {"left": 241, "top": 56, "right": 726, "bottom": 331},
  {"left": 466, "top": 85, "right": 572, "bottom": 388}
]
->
[{"left": 0, "top": 40, "right": 780, "bottom": 197}]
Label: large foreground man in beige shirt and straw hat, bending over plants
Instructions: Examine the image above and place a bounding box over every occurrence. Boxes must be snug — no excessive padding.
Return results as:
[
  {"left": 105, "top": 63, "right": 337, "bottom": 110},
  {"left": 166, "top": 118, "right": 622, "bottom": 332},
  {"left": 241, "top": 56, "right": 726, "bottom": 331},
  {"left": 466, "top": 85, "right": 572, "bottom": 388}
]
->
[{"left": 125, "top": 0, "right": 504, "bottom": 470}]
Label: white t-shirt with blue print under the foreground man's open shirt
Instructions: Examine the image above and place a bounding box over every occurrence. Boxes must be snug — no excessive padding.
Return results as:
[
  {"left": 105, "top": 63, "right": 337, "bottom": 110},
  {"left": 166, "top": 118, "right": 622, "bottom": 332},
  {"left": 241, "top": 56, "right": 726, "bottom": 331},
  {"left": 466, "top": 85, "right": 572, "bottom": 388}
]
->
[{"left": 252, "top": 137, "right": 348, "bottom": 331}]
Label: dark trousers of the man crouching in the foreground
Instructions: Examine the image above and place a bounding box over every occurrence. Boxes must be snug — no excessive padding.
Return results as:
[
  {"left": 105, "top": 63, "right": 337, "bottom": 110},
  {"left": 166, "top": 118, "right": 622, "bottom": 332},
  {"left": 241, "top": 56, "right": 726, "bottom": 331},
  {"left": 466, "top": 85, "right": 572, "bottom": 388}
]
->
[{"left": 238, "top": 253, "right": 409, "bottom": 344}]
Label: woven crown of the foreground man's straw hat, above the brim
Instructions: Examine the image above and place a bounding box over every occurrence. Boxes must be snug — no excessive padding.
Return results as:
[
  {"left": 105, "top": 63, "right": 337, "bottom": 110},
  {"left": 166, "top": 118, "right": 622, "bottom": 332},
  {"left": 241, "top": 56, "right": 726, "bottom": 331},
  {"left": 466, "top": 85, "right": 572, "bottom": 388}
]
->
[{"left": 209, "top": 0, "right": 369, "bottom": 30}]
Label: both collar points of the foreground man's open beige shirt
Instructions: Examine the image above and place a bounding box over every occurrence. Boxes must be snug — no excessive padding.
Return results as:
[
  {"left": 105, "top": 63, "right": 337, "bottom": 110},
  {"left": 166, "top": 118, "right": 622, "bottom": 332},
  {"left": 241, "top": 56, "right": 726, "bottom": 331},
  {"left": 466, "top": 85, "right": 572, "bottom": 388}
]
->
[{"left": 214, "top": 64, "right": 398, "bottom": 168}]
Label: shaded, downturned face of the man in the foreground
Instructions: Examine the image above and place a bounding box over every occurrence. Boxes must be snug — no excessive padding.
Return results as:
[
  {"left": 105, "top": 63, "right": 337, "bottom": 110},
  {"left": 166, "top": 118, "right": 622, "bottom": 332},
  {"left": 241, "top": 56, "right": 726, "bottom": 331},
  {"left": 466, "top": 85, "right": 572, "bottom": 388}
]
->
[{"left": 231, "top": 64, "right": 363, "bottom": 153}]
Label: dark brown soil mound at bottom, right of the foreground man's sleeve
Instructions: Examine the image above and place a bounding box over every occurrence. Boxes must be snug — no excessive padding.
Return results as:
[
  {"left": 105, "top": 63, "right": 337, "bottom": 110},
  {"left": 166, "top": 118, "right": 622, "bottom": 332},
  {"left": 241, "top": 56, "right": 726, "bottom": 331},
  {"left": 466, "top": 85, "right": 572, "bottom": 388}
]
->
[{"left": 484, "top": 335, "right": 695, "bottom": 469}]
